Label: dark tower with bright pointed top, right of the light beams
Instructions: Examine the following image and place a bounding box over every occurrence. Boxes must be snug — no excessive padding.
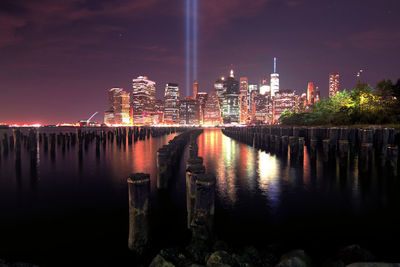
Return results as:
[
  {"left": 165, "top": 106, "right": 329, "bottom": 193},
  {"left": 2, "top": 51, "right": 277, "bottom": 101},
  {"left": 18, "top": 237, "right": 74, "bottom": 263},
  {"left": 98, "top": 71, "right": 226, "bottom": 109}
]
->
[{"left": 222, "top": 70, "right": 240, "bottom": 123}]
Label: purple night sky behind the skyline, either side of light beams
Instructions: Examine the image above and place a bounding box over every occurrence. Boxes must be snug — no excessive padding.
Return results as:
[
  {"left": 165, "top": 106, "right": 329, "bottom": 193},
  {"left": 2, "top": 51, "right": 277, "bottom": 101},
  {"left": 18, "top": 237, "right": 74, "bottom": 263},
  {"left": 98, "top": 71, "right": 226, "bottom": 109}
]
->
[{"left": 0, "top": 0, "right": 400, "bottom": 123}]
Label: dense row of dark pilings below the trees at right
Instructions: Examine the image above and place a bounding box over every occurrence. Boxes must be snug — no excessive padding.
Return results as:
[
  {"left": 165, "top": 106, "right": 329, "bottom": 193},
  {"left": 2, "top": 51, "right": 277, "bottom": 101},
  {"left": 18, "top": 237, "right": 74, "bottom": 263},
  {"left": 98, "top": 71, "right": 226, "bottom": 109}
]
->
[{"left": 222, "top": 126, "right": 400, "bottom": 176}]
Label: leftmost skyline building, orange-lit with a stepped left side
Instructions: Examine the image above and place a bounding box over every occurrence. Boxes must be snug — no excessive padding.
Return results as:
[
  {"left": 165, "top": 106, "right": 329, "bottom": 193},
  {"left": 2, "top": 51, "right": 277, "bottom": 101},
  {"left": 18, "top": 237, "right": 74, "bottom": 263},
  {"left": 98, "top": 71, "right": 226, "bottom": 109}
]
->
[{"left": 104, "top": 88, "right": 130, "bottom": 124}]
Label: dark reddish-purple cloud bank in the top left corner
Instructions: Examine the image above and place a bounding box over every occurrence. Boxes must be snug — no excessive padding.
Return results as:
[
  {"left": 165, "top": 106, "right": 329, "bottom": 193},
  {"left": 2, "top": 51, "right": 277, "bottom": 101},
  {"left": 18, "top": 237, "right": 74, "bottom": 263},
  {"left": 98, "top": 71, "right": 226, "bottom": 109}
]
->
[{"left": 0, "top": 0, "right": 168, "bottom": 47}]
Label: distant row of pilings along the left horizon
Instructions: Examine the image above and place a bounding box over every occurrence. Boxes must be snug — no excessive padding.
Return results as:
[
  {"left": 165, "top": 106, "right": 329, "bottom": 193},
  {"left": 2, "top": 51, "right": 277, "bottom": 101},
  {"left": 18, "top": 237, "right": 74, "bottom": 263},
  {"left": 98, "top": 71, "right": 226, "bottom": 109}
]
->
[{"left": 0, "top": 127, "right": 186, "bottom": 163}]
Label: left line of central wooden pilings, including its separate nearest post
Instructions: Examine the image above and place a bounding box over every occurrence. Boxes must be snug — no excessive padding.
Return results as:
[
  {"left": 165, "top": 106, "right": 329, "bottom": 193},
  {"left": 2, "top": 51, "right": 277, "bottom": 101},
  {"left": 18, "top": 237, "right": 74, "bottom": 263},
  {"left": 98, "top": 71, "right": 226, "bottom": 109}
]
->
[{"left": 128, "top": 128, "right": 206, "bottom": 256}]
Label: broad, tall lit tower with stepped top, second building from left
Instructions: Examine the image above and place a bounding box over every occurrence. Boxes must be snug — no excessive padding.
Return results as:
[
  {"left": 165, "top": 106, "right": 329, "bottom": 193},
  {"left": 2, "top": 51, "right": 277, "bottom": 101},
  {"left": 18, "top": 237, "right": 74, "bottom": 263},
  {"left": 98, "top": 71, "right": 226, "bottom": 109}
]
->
[{"left": 131, "top": 76, "right": 156, "bottom": 124}]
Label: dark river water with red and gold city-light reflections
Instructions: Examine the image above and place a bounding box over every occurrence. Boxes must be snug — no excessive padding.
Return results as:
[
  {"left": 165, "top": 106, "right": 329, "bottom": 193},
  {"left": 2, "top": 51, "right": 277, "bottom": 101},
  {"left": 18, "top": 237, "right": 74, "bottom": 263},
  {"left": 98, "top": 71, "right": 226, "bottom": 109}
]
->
[{"left": 0, "top": 129, "right": 400, "bottom": 266}]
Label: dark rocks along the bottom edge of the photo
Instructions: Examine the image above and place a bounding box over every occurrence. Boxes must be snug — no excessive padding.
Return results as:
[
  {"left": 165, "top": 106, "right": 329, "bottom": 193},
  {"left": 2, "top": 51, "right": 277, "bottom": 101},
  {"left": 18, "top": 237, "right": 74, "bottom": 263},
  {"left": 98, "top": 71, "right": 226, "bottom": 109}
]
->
[{"left": 149, "top": 241, "right": 400, "bottom": 267}]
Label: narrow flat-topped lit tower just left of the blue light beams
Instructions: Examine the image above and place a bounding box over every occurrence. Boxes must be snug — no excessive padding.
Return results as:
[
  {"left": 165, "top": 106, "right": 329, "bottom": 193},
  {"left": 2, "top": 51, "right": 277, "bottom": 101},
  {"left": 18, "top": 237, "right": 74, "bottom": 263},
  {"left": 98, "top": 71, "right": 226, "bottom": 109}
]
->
[{"left": 164, "top": 83, "right": 180, "bottom": 124}]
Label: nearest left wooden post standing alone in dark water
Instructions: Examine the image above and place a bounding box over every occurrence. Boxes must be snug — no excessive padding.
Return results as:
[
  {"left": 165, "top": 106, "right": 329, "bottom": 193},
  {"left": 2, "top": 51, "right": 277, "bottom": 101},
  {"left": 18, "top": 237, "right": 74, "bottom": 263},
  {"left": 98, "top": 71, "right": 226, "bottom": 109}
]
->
[{"left": 128, "top": 173, "right": 150, "bottom": 255}]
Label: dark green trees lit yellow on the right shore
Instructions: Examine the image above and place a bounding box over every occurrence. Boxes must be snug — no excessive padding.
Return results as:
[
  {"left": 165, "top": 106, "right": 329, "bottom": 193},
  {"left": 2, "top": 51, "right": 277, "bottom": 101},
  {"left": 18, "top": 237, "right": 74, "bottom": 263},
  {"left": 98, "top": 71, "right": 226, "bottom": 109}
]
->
[{"left": 279, "top": 79, "right": 400, "bottom": 126}]
